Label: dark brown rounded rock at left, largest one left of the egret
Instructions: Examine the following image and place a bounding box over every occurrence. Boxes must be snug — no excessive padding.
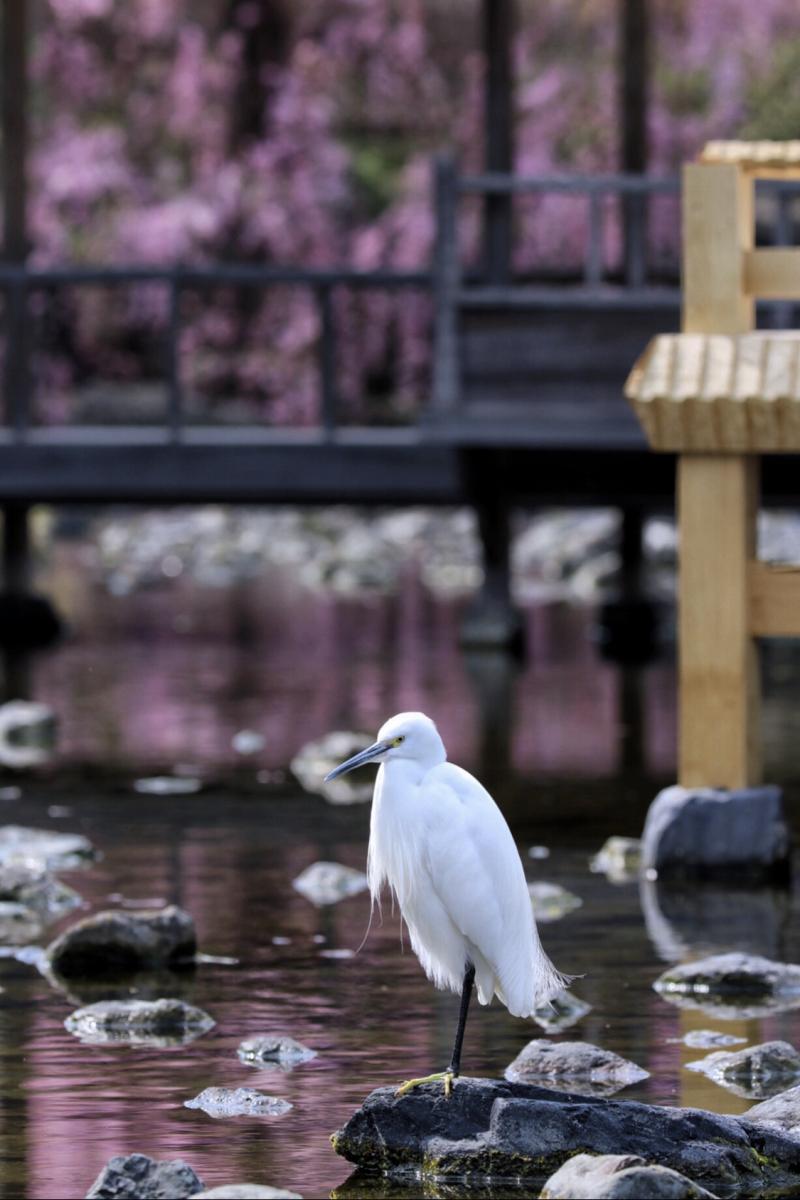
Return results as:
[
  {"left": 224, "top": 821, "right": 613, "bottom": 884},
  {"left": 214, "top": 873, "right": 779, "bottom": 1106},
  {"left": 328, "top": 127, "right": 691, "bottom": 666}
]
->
[{"left": 47, "top": 905, "right": 197, "bottom": 978}]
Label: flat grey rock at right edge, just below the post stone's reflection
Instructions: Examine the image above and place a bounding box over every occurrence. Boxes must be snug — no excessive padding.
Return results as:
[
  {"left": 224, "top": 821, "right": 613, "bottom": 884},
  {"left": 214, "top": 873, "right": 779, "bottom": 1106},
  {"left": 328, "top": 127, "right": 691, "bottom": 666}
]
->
[{"left": 652, "top": 952, "right": 800, "bottom": 1019}]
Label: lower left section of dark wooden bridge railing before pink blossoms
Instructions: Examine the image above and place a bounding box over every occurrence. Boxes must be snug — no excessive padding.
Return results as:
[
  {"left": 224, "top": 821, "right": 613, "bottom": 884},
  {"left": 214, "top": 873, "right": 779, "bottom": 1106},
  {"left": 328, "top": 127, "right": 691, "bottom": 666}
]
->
[{"left": 0, "top": 263, "right": 431, "bottom": 443}]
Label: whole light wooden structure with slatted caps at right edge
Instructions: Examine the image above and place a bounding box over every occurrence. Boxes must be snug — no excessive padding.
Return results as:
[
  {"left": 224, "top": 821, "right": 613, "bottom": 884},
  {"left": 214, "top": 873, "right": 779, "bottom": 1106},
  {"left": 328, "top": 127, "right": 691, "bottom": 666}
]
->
[{"left": 625, "top": 142, "right": 800, "bottom": 788}]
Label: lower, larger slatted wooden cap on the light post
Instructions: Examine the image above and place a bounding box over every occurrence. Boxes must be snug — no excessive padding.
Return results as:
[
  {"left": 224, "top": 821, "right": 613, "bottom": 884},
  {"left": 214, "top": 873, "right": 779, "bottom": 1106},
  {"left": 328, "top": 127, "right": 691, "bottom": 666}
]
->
[{"left": 625, "top": 331, "right": 800, "bottom": 452}]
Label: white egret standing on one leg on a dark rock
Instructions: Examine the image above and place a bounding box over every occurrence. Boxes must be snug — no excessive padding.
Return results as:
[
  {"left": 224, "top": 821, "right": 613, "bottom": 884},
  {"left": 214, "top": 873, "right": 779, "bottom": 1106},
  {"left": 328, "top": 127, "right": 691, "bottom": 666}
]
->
[{"left": 327, "top": 713, "right": 571, "bottom": 1096}]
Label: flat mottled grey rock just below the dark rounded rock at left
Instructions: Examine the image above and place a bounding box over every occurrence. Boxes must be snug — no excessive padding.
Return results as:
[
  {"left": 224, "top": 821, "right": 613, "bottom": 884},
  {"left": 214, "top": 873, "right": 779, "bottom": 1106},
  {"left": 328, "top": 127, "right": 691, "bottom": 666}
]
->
[{"left": 64, "top": 1000, "right": 216, "bottom": 1046}]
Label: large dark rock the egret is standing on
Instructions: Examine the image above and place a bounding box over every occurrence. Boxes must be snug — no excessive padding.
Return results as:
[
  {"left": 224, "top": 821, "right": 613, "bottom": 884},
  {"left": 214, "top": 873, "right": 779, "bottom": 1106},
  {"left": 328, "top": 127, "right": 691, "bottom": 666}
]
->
[{"left": 332, "top": 1079, "right": 800, "bottom": 1200}]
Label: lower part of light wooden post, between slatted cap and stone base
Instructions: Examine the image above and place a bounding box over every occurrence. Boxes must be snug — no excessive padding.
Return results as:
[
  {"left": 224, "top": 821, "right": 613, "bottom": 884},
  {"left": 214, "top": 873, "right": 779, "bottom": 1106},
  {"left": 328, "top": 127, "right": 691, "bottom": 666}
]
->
[{"left": 678, "top": 455, "right": 760, "bottom": 787}]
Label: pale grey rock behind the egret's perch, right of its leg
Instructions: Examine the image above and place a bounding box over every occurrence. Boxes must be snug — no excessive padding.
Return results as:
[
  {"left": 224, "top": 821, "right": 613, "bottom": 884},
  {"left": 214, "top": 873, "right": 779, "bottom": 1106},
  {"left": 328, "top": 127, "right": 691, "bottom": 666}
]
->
[{"left": 505, "top": 1038, "right": 650, "bottom": 1096}]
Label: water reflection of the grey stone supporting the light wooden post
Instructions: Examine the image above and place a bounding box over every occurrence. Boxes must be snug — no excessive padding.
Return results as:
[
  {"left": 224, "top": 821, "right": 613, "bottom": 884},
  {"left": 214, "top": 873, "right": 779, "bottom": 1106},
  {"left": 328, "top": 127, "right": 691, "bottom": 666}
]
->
[{"left": 639, "top": 878, "right": 790, "bottom": 962}]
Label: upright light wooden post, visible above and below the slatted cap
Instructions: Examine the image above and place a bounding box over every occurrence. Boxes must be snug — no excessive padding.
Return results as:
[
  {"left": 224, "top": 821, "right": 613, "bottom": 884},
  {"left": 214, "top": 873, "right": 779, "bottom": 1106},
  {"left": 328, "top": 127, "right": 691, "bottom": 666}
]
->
[{"left": 678, "top": 163, "right": 760, "bottom": 788}]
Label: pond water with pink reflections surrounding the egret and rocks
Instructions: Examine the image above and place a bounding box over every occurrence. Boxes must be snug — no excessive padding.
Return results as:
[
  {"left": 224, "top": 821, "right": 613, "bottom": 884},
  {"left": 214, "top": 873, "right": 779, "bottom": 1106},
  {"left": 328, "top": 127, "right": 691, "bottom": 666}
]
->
[{"left": 0, "top": 561, "right": 800, "bottom": 1200}]
